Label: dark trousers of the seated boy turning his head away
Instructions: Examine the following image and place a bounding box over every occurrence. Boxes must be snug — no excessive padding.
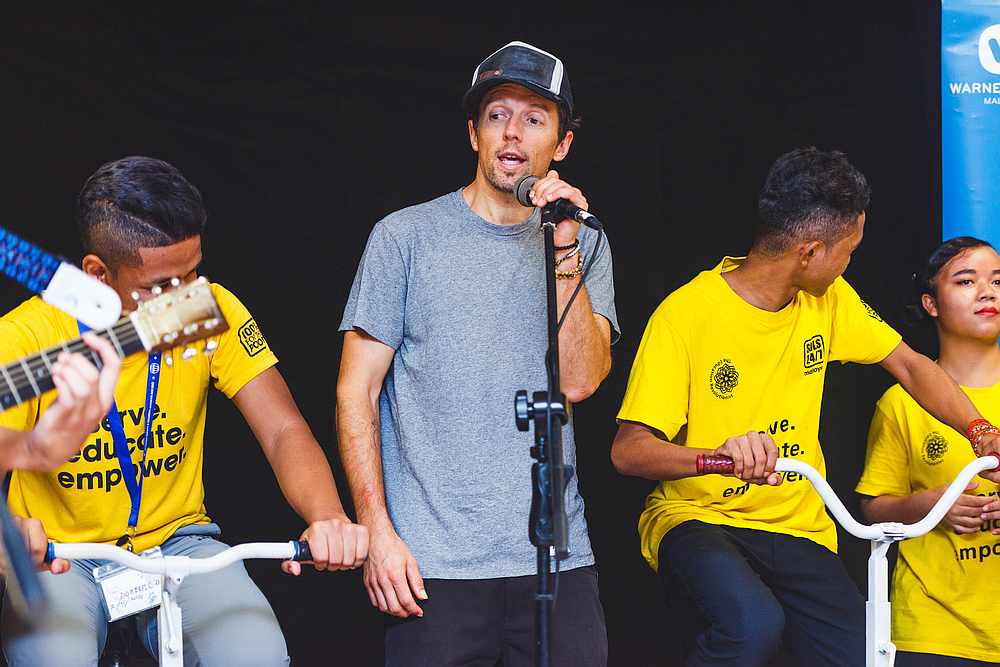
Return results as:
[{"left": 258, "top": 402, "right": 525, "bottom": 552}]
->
[{"left": 659, "top": 521, "right": 865, "bottom": 667}]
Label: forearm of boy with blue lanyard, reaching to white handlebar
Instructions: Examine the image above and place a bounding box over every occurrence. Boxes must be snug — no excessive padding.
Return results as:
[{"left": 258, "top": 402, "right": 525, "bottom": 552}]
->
[{"left": 265, "top": 423, "right": 346, "bottom": 523}]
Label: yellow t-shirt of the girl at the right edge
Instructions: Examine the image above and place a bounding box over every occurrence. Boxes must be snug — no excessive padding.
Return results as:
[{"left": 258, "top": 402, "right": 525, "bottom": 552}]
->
[{"left": 857, "top": 384, "right": 1000, "bottom": 662}]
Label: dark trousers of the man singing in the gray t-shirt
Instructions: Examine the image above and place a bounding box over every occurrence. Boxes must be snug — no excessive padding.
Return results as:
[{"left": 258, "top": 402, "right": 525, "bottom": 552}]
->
[{"left": 385, "top": 566, "right": 608, "bottom": 667}]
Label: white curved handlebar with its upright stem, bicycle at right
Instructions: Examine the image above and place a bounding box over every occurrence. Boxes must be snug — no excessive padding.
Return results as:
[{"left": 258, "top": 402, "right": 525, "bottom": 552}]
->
[{"left": 775, "top": 456, "right": 1000, "bottom": 667}]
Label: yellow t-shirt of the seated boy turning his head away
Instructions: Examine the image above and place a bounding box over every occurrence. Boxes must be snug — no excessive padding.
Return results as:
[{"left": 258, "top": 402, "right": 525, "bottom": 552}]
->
[{"left": 618, "top": 257, "right": 901, "bottom": 570}]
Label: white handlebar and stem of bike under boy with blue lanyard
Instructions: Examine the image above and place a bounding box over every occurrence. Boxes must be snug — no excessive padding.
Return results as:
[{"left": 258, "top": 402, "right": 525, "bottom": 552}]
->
[{"left": 48, "top": 541, "right": 310, "bottom": 667}]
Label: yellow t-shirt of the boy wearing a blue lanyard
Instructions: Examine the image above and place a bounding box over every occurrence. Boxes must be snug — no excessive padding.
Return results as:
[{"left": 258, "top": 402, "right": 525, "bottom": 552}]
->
[{"left": 0, "top": 284, "right": 278, "bottom": 551}]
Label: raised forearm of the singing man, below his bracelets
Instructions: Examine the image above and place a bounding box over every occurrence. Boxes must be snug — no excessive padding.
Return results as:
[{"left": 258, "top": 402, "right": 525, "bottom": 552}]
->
[{"left": 556, "top": 278, "right": 611, "bottom": 401}]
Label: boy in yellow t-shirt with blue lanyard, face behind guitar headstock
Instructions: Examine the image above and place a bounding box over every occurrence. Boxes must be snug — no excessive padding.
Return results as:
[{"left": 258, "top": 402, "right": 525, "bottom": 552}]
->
[{"left": 0, "top": 157, "right": 367, "bottom": 667}]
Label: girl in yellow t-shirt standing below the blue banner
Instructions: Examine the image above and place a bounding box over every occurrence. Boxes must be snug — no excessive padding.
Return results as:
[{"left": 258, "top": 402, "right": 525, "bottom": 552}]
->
[{"left": 857, "top": 236, "right": 1000, "bottom": 667}]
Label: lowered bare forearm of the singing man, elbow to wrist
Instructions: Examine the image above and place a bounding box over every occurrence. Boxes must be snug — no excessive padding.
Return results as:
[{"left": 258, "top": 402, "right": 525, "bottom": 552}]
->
[{"left": 337, "top": 390, "right": 391, "bottom": 528}]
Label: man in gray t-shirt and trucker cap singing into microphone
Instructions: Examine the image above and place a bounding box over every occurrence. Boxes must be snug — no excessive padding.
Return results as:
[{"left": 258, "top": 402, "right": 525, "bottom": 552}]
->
[{"left": 337, "top": 42, "right": 618, "bottom": 665}]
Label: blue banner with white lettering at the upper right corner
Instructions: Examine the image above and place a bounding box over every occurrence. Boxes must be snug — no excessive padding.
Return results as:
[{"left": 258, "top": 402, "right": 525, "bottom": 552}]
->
[{"left": 941, "top": 0, "right": 1000, "bottom": 243}]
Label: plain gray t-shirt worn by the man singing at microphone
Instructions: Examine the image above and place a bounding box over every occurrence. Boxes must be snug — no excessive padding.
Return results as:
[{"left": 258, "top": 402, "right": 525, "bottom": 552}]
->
[{"left": 340, "top": 190, "right": 618, "bottom": 579}]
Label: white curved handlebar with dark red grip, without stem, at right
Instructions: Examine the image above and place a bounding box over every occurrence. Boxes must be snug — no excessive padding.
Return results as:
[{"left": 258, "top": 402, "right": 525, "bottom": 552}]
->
[{"left": 699, "top": 454, "right": 1000, "bottom": 540}]
